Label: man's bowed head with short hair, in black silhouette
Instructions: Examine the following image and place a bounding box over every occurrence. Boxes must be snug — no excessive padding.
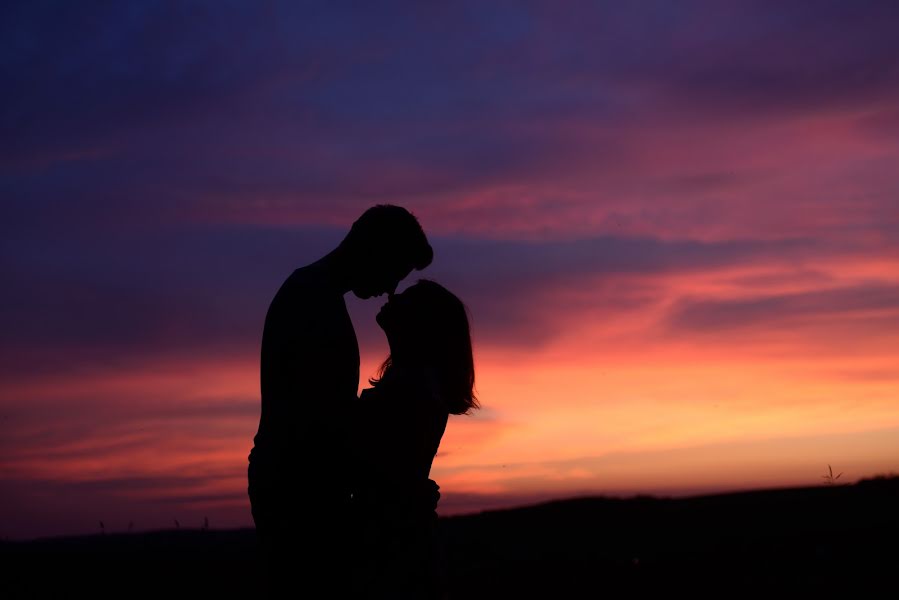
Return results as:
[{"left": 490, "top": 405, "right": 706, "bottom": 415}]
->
[{"left": 338, "top": 204, "right": 434, "bottom": 298}]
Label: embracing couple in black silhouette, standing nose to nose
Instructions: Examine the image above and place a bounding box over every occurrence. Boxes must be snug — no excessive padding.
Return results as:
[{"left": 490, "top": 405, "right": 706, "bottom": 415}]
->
[{"left": 248, "top": 205, "right": 477, "bottom": 598}]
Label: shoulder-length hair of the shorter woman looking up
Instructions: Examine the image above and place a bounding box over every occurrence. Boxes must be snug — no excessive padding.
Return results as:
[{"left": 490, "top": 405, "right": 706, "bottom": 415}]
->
[{"left": 369, "top": 279, "right": 479, "bottom": 415}]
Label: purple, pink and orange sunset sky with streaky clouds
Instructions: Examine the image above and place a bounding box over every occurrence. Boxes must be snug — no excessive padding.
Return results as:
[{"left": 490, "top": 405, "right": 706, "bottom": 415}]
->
[{"left": 0, "top": 0, "right": 899, "bottom": 539}]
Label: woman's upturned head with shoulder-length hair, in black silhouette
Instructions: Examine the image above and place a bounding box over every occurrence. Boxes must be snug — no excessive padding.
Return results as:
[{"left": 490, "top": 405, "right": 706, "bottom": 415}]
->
[{"left": 377, "top": 279, "right": 478, "bottom": 414}]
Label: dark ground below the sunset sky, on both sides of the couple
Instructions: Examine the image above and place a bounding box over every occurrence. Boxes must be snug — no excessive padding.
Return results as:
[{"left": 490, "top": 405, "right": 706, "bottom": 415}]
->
[{"left": 0, "top": 477, "right": 899, "bottom": 599}]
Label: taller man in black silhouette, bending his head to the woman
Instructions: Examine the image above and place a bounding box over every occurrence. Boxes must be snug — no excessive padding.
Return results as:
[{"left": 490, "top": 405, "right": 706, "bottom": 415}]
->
[{"left": 248, "top": 205, "right": 433, "bottom": 597}]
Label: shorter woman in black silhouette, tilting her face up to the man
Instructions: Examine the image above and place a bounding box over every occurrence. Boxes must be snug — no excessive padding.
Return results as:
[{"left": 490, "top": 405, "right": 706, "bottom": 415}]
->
[{"left": 351, "top": 280, "right": 478, "bottom": 598}]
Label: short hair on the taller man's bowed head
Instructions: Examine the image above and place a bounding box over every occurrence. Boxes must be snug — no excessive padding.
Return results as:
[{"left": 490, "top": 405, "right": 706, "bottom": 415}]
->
[{"left": 340, "top": 204, "right": 434, "bottom": 271}]
